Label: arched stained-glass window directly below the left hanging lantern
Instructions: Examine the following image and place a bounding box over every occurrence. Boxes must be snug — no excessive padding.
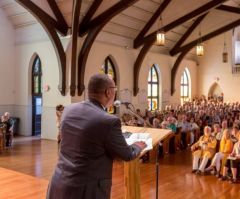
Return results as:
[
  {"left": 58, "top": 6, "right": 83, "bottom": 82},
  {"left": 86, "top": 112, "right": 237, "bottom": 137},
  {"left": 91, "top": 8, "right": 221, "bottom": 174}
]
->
[{"left": 148, "top": 65, "right": 159, "bottom": 111}]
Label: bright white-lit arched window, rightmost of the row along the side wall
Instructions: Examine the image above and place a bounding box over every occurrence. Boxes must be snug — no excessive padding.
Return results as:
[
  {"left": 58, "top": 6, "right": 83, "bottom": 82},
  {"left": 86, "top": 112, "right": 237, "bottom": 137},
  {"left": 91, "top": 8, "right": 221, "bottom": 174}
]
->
[{"left": 180, "top": 68, "right": 190, "bottom": 103}]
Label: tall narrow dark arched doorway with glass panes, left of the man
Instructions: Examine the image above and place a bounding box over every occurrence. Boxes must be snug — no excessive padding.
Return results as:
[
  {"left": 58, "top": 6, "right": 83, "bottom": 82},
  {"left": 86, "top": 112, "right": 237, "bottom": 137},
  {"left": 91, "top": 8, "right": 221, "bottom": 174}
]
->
[{"left": 32, "top": 56, "right": 42, "bottom": 136}]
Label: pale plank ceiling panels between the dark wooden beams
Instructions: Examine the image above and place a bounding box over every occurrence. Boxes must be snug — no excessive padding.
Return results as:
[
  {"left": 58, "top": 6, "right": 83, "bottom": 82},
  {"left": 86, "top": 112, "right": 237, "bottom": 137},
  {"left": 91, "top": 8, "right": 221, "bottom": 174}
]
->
[{"left": 0, "top": 0, "right": 240, "bottom": 53}]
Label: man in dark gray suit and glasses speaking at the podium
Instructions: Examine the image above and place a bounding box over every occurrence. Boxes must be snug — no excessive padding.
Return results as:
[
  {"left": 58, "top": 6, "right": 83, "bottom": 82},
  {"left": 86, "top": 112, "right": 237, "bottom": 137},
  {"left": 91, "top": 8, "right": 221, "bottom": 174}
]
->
[{"left": 47, "top": 74, "right": 146, "bottom": 199}]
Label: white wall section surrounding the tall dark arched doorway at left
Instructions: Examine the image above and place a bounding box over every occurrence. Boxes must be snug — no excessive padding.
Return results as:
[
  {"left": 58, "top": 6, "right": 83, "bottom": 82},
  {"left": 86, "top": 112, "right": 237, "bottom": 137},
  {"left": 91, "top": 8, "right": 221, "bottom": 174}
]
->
[{"left": 15, "top": 38, "right": 71, "bottom": 139}]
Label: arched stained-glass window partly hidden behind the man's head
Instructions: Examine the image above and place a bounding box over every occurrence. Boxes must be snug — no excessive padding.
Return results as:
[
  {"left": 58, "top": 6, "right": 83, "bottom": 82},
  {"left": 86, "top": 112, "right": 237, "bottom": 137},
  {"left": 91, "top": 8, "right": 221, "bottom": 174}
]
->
[{"left": 100, "top": 56, "right": 117, "bottom": 114}]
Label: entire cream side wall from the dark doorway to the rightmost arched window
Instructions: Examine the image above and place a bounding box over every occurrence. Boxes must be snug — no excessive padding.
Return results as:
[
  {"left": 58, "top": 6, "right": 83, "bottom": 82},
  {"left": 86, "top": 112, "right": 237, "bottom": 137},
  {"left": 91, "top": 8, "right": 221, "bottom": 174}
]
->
[{"left": 15, "top": 28, "right": 197, "bottom": 139}]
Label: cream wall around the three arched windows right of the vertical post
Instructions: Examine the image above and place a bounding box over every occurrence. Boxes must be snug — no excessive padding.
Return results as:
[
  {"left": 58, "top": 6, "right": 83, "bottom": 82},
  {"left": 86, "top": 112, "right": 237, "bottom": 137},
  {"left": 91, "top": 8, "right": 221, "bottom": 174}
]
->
[{"left": 82, "top": 42, "right": 197, "bottom": 110}]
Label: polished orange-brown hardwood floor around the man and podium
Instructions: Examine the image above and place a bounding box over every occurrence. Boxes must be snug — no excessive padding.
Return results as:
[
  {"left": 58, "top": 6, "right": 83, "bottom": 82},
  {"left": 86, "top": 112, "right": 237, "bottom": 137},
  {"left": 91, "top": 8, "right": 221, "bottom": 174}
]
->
[{"left": 0, "top": 139, "right": 240, "bottom": 199}]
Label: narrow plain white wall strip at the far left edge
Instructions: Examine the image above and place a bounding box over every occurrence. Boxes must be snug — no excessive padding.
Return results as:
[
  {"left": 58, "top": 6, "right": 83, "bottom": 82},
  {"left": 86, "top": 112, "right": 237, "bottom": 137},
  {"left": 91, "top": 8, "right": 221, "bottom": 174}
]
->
[{"left": 0, "top": 9, "right": 15, "bottom": 105}]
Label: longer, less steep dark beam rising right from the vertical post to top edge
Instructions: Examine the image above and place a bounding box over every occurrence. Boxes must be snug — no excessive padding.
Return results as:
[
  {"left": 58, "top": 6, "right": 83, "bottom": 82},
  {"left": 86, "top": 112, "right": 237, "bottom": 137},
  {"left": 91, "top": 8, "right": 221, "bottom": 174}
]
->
[{"left": 80, "top": 0, "right": 139, "bottom": 35}]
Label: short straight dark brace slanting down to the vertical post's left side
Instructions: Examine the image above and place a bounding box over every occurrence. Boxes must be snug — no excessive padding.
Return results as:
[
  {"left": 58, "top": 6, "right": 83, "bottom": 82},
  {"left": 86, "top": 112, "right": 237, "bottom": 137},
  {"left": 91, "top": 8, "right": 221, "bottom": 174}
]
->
[{"left": 47, "top": 0, "right": 68, "bottom": 35}]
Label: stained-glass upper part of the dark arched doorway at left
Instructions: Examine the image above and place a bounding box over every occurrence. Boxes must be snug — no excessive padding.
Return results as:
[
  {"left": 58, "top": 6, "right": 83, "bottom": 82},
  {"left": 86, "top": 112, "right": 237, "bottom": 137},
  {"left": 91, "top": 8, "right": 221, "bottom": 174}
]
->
[{"left": 32, "top": 56, "right": 42, "bottom": 95}]
